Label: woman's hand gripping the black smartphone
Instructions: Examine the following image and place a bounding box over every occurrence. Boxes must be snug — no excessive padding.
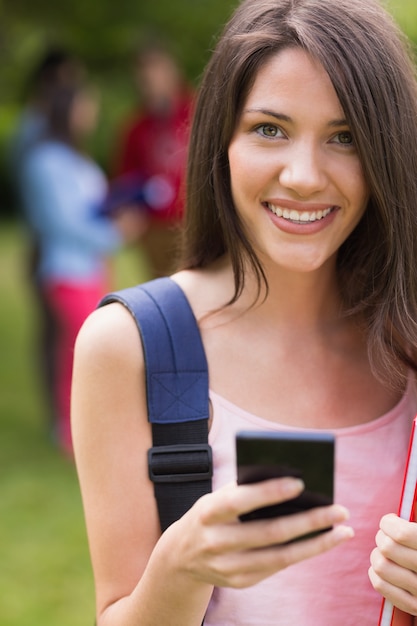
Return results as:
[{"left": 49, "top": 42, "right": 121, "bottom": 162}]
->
[{"left": 157, "top": 478, "right": 354, "bottom": 588}]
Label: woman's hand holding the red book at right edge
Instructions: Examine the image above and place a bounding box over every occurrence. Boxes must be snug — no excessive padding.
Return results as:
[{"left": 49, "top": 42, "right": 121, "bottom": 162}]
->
[{"left": 368, "top": 513, "right": 417, "bottom": 615}]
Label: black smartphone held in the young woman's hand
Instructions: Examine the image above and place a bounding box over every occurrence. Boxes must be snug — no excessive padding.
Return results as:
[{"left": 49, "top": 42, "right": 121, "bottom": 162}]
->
[{"left": 236, "top": 431, "right": 335, "bottom": 530}]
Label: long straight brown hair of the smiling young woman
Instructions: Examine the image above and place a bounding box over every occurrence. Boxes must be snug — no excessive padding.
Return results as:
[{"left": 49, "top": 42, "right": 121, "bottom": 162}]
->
[{"left": 183, "top": 0, "right": 417, "bottom": 377}]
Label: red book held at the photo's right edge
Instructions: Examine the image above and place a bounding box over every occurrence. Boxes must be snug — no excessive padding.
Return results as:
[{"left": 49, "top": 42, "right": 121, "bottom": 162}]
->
[{"left": 378, "top": 416, "right": 417, "bottom": 626}]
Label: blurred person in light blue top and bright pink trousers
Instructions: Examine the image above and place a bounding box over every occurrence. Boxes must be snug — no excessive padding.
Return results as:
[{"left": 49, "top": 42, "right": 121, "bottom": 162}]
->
[{"left": 19, "top": 83, "right": 142, "bottom": 454}]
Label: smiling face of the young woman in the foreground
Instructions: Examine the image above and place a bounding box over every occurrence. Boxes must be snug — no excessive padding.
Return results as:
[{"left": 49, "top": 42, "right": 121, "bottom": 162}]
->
[{"left": 228, "top": 48, "right": 369, "bottom": 272}]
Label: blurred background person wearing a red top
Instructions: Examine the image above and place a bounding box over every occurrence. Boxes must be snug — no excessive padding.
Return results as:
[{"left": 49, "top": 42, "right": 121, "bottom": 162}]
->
[{"left": 114, "top": 42, "right": 193, "bottom": 277}]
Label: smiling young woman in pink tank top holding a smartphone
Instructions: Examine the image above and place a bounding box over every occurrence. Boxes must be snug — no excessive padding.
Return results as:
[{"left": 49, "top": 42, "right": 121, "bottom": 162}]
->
[{"left": 73, "top": 0, "right": 417, "bottom": 626}]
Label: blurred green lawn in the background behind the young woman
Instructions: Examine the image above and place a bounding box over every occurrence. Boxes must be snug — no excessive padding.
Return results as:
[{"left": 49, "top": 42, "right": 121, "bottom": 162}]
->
[{"left": 0, "top": 222, "right": 150, "bottom": 626}]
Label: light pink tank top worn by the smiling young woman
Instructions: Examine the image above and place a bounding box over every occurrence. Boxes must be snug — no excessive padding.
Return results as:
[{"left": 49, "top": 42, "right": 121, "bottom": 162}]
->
[{"left": 204, "top": 382, "right": 417, "bottom": 626}]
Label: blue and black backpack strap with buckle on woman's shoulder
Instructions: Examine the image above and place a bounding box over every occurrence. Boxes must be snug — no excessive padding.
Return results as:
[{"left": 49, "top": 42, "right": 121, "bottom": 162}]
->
[{"left": 99, "top": 278, "right": 212, "bottom": 531}]
